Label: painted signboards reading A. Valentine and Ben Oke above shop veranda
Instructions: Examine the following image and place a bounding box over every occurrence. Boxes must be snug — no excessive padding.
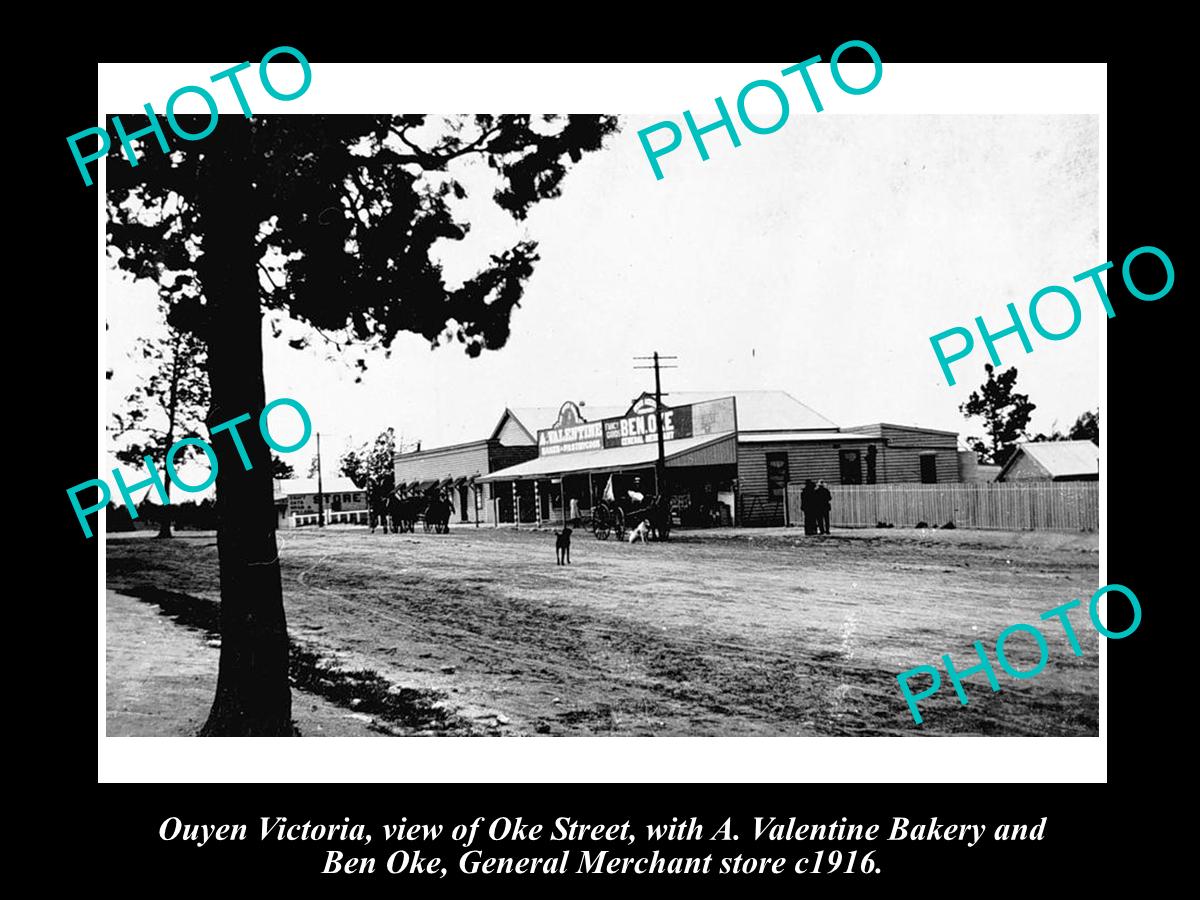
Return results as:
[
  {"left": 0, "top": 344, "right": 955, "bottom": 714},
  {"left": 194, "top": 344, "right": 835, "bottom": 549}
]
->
[{"left": 538, "top": 397, "right": 736, "bottom": 456}]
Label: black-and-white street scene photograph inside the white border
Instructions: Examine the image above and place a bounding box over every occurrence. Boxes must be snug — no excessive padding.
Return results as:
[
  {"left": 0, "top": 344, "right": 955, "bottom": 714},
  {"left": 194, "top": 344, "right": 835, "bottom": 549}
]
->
[{"left": 98, "top": 77, "right": 1099, "bottom": 738}]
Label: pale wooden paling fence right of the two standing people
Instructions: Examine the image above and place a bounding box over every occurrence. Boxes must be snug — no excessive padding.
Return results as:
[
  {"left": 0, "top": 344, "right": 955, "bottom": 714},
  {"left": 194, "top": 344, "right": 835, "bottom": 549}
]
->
[{"left": 787, "top": 481, "right": 1100, "bottom": 532}]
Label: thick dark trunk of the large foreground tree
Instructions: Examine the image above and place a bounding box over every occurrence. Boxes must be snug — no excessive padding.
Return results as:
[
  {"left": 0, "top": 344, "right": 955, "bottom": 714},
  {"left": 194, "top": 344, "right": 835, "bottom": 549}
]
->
[{"left": 193, "top": 127, "right": 294, "bottom": 737}]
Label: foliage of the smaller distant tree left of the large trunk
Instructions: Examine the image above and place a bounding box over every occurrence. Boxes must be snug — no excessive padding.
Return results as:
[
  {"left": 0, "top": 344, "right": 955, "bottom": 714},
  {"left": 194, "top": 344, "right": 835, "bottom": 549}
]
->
[{"left": 109, "top": 328, "right": 209, "bottom": 538}]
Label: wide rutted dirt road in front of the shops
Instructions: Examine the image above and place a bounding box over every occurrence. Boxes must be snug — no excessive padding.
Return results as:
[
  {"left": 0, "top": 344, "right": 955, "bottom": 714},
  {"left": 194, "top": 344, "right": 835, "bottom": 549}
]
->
[{"left": 108, "top": 527, "right": 1099, "bottom": 736}]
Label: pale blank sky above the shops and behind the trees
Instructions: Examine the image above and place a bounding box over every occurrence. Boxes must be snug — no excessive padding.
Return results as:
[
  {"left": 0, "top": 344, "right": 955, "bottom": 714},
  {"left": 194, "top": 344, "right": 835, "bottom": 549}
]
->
[{"left": 107, "top": 115, "right": 1109, "bottom": 489}]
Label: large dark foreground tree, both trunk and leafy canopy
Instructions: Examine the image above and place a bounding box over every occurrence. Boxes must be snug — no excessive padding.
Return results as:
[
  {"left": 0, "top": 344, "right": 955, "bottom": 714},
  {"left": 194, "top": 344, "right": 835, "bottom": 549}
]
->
[{"left": 106, "top": 109, "right": 617, "bottom": 736}]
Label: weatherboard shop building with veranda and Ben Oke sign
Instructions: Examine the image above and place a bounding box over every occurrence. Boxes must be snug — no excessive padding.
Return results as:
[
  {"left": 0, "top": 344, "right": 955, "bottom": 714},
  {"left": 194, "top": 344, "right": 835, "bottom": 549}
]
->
[{"left": 472, "top": 391, "right": 959, "bottom": 527}]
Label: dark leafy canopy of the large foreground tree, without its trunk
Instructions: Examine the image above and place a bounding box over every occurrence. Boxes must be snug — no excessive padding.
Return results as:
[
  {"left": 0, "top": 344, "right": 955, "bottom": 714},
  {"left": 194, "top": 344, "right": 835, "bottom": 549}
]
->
[{"left": 108, "top": 115, "right": 617, "bottom": 355}]
